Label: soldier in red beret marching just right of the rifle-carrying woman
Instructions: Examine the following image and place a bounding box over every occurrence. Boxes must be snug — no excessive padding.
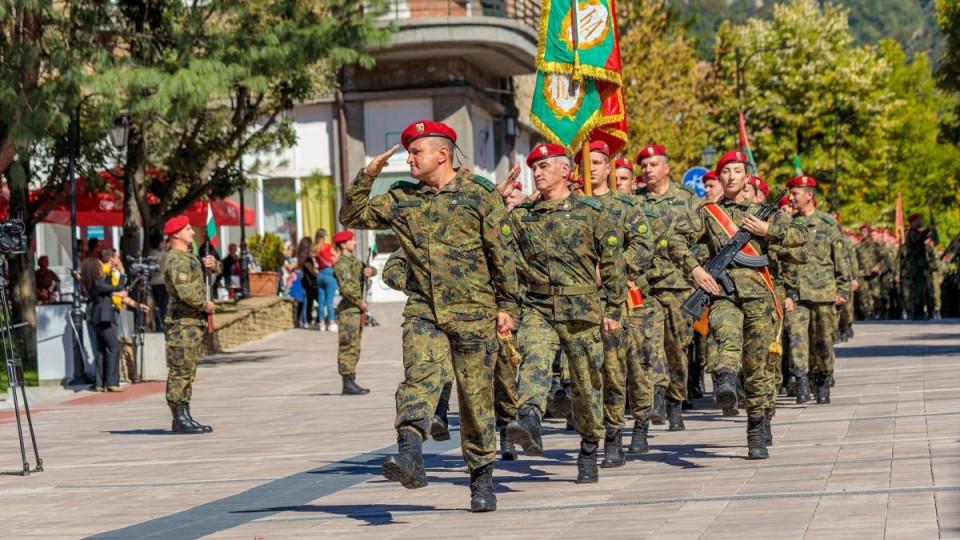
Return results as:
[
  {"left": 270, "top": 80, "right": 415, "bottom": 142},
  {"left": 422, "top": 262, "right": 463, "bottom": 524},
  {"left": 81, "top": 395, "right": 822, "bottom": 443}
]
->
[{"left": 784, "top": 176, "right": 850, "bottom": 404}]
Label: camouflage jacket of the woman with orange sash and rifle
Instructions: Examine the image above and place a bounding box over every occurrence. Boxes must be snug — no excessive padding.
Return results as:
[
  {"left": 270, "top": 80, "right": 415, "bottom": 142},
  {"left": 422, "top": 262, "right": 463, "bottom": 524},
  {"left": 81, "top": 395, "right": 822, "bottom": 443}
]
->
[{"left": 671, "top": 199, "right": 807, "bottom": 298}]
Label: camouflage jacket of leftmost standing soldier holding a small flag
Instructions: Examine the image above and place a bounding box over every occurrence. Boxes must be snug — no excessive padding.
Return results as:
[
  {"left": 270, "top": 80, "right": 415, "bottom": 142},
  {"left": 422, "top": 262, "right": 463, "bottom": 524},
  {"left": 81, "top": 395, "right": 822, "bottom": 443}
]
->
[{"left": 163, "top": 249, "right": 221, "bottom": 326}]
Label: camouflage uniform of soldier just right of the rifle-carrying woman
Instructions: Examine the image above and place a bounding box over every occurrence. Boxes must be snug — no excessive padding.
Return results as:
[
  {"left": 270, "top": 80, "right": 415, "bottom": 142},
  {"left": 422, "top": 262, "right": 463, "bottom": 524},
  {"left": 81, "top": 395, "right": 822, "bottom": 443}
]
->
[{"left": 786, "top": 210, "right": 850, "bottom": 377}]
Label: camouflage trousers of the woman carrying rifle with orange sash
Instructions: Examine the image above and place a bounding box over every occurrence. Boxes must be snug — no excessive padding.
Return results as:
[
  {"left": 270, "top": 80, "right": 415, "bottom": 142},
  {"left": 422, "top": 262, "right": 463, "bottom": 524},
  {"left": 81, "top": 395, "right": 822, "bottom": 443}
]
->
[{"left": 709, "top": 296, "right": 781, "bottom": 414}]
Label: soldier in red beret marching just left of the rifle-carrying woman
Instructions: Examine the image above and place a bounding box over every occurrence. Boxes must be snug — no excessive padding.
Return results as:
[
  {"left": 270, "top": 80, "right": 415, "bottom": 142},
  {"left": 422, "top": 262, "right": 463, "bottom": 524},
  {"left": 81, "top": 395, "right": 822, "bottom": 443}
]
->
[{"left": 637, "top": 144, "right": 700, "bottom": 431}]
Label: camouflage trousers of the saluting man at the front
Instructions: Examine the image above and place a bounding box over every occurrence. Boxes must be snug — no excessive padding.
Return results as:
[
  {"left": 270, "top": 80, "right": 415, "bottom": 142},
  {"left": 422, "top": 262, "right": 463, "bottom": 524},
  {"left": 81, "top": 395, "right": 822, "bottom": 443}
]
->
[{"left": 394, "top": 317, "right": 499, "bottom": 470}]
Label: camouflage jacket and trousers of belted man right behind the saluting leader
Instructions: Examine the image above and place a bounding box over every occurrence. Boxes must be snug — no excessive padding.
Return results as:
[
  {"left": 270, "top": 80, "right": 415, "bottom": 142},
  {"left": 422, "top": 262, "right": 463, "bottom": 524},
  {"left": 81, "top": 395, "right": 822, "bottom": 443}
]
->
[{"left": 510, "top": 193, "right": 626, "bottom": 443}]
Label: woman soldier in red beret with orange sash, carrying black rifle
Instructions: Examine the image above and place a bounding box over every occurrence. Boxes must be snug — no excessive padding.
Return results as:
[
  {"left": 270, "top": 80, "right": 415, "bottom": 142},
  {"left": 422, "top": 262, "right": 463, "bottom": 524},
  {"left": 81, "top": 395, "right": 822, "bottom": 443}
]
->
[{"left": 671, "top": 151, "right": 806, "bottom": 459}]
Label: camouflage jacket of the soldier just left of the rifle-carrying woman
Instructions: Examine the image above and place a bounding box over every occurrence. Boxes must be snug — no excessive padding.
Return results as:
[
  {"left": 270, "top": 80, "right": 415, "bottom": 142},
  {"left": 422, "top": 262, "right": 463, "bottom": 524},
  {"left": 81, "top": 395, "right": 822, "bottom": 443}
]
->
[{"left": 637, "top": 182, "right": 700, "bottom": 295}]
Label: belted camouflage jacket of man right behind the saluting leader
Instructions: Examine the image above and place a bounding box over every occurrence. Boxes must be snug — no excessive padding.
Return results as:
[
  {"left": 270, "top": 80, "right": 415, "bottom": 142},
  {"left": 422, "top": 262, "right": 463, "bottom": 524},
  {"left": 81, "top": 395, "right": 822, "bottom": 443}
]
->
[{"left": 510, "top": 193, "right": 626, "bottom": 324}]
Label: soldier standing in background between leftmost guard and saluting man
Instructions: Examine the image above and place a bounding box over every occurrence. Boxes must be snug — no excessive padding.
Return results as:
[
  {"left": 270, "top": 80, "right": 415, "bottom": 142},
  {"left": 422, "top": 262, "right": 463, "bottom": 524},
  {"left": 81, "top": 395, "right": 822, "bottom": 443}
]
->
[{"left": 333, "top": 231, "right": 377, "bottom": 395}]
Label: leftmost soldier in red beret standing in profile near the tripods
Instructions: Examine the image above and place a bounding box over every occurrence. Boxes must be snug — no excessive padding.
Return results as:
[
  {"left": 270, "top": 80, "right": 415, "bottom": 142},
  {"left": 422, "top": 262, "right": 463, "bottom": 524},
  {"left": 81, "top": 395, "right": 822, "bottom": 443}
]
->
[{"left": 163, "top": 216, "right": 221, "bottom": 433}]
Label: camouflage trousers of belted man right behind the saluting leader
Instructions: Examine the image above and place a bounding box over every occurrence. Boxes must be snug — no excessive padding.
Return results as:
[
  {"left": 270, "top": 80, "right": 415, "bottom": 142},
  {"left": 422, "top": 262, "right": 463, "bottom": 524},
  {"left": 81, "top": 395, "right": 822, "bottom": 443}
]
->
[{"left": 517, "top": 309, "right": 604, "bottom": 442}]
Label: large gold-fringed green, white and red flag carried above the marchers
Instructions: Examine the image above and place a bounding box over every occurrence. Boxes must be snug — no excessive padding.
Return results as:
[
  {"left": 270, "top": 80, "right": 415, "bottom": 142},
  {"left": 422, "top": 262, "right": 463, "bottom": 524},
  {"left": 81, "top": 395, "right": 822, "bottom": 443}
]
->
[{"left": 530, "top": 0, "right": 627, "bottom": 155}]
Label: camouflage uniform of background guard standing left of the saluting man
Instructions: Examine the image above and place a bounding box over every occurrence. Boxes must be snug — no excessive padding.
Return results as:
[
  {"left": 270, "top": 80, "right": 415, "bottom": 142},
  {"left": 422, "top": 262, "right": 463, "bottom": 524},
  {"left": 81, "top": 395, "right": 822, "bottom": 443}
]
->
[{"left": 333, "top": 255, "right": 374, "bottom": 376}]
